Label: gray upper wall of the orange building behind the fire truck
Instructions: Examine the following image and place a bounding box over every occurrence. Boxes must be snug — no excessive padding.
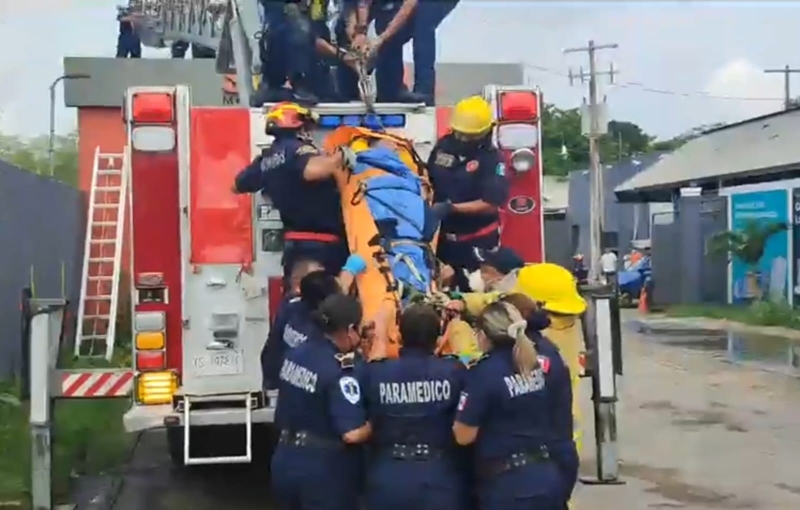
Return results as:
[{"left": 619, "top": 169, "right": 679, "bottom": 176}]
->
[{"left": 64, "top": 57, "right": 525, "bottom": 107}]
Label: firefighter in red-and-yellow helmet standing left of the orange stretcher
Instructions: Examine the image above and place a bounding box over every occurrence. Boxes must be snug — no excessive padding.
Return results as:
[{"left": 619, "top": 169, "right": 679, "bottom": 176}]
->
[{"left": 233, "top": 102, "right": 355, "bottom": 288}]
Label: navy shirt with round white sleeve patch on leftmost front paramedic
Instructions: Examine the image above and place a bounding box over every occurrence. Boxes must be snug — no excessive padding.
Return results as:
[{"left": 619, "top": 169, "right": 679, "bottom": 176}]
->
[{"left": 275, "top": 336, "right": 367, "bottom": 441}]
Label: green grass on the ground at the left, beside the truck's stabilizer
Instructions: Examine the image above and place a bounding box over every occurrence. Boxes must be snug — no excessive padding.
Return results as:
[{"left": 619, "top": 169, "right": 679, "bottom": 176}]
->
[{"left": 0, "top": 349, "right": 134, "bottom": 508}]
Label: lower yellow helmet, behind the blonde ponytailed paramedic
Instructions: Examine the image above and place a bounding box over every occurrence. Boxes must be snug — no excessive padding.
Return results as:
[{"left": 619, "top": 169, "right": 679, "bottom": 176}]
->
[{"left": 514, "top": 263, "right": 586, "bottom": 315}]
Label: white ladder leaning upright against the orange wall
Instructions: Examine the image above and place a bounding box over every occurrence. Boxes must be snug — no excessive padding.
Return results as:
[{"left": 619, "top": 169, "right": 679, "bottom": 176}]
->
[{"left": 75, "top": 147, "right": 128, "bottom": 360}]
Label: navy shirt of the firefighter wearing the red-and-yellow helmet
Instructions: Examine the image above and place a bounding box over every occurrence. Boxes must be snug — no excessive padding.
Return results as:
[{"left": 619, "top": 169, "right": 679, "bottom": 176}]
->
[{"left": 231, "top": 137, "right": 344, "bottom": 237}]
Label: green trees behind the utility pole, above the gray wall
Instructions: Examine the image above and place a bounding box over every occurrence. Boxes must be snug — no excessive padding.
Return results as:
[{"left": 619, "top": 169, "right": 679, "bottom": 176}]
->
[{"left": 542, "top": 104, "right": 654, "bottom": 175}]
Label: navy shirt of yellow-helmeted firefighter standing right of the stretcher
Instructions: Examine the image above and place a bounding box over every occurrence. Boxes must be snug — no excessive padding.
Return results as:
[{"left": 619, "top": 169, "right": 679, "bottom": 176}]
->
[{"left": 428, "top": 134, "right": 508, "bottom": 234}]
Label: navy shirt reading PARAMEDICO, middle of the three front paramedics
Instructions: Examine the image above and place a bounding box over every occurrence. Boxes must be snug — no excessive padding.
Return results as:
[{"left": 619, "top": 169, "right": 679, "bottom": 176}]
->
[{"left": 365, "top": 348, "right": 466, "bottom": 448}]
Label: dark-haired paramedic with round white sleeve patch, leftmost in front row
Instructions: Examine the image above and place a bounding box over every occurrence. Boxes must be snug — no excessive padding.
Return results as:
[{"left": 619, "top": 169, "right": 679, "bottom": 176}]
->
[{"left": 271, "top": 294, "right": 372, "bottom": 510}]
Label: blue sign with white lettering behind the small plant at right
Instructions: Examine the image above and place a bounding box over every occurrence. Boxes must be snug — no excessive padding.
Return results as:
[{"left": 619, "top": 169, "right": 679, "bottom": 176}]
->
[{"left": 731, "top": 189, "right": 791, "bottom": 303}]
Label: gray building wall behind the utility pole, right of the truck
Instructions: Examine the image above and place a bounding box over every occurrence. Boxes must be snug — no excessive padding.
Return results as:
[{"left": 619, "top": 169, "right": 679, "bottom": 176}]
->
[{"left": 567, "top": 150, "right": 661, "bottom": 256}]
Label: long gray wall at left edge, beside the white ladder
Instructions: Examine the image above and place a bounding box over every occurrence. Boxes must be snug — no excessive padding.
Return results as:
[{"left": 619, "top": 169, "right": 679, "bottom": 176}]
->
[{"left": 0, "top": 161, "right": 85, "bottom": 380}]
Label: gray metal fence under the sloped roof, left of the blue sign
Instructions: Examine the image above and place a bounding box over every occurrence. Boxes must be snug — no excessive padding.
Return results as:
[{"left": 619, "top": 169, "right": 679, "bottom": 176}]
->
[{"left": 651, "top": 197, "right": 729, "bottom": 305}]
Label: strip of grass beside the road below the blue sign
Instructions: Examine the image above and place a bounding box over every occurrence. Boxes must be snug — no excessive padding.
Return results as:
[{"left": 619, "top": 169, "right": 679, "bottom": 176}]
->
[{"left": 664, "top": 301, "right": 800, "bottom": 330}]
